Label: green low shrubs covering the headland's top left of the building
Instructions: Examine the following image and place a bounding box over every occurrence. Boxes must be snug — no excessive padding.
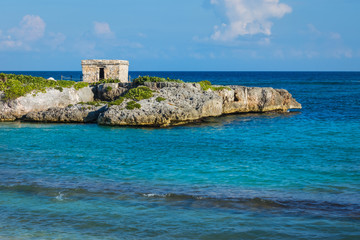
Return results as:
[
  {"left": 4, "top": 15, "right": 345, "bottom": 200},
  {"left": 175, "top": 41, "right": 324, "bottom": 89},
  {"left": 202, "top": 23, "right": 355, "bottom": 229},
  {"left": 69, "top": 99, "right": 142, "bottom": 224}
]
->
[{"left": 0, "top": 73, "right": 89, "bottom": 100}]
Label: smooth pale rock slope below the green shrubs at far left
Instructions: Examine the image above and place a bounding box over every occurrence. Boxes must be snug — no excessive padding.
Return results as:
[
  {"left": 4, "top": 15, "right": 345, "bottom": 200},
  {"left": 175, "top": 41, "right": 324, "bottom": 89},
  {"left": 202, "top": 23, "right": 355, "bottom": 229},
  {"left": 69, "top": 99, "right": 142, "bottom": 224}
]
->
[{"left": 0, "top": 87, "right": 94, "bottom": 121}]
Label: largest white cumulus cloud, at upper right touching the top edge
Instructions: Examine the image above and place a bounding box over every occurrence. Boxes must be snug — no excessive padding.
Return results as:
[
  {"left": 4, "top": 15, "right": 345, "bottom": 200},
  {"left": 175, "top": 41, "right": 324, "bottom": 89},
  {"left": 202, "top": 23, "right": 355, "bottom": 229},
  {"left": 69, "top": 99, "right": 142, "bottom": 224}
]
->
[{"left": 210, "top": 0, "right": 292, "bottom": 41}]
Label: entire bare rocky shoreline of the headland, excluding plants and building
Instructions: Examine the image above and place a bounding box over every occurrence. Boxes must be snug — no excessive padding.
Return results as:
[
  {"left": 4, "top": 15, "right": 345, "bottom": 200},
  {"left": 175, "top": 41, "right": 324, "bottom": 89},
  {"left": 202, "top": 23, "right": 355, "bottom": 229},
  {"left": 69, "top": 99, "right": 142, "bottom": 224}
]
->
[{"left": 0, "top": 82, "right": 301, "bottom": 127}]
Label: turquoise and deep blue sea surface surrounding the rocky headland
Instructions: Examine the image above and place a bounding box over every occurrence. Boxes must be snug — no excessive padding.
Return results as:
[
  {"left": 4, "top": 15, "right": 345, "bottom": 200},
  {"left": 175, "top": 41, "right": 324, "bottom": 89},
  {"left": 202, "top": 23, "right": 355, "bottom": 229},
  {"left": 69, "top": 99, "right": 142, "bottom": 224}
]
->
[{"left": 0, "top": 72, "right": 360, "bottom": 239}]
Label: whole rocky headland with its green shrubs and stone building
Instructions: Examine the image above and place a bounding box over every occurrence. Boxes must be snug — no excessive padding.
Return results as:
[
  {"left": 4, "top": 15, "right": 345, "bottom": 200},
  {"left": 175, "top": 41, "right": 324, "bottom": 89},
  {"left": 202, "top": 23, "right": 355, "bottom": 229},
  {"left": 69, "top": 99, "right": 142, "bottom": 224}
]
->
[{"left": 0, "top": 60, "right": 301, "bottom": 127}]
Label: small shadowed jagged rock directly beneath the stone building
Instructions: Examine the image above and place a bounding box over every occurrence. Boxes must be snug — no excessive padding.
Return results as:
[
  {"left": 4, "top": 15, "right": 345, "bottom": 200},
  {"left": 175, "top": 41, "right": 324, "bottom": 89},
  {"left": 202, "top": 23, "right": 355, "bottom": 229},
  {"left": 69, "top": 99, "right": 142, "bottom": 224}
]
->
[{"left": 96, "top": 83, "right": 128, "bottom": 101}]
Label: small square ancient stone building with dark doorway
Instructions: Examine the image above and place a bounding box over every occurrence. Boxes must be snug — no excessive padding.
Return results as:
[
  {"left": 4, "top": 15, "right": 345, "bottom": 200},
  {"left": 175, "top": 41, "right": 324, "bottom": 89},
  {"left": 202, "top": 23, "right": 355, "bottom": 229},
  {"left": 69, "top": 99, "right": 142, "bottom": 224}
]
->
[{"left": 81, "top": 60, "right": 129, "bottom": 83}]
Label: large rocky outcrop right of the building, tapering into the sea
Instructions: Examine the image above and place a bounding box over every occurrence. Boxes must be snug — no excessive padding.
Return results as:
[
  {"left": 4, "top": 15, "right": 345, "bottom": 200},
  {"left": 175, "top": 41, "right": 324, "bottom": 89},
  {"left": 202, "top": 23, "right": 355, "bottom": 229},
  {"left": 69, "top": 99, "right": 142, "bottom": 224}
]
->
[{"left": 98, "top": 82, "right": 301, "bottom": 126}]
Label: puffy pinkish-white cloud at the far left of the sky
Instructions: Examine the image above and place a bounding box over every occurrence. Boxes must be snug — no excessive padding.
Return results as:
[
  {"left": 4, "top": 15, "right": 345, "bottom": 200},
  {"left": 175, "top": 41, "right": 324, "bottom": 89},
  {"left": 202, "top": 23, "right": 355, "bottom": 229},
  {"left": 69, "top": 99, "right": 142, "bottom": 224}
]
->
[{"left": 0, "top": 15, "right": 46, "bottom": 50}]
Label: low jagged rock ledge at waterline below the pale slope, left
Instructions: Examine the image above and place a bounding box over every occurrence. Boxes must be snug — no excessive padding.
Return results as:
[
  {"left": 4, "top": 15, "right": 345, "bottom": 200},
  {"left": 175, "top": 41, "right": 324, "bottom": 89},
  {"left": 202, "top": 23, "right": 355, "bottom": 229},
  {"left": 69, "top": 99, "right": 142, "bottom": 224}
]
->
[{"left": 24, "top": 104, "right": 106, "bottom": 123}]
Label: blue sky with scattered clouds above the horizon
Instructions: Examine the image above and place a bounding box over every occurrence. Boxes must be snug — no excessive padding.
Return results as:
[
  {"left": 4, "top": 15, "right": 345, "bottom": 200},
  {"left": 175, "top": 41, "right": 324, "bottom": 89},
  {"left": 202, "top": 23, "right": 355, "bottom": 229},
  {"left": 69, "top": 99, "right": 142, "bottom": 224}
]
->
[{"left": 0, "top": 0, "right": 360, "bottom": 71}]
